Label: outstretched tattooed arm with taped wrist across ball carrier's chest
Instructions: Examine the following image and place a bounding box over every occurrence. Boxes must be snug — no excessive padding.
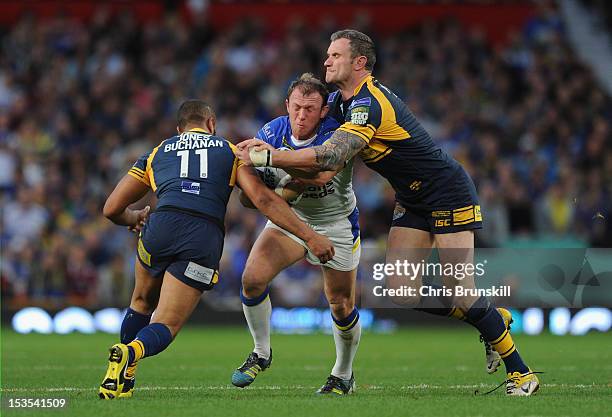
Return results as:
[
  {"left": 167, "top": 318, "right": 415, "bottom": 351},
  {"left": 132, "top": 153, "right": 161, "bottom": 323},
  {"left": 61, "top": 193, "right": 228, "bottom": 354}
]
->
[{"left": 240, "top": 130, "right": 366, "bottom": 171}]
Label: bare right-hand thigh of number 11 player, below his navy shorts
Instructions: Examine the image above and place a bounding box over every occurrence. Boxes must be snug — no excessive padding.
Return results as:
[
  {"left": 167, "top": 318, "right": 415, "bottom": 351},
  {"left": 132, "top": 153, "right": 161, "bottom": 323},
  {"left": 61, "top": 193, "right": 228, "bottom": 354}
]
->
[{"left": 151, "top": 271, "right": 202, "bottom": 337}]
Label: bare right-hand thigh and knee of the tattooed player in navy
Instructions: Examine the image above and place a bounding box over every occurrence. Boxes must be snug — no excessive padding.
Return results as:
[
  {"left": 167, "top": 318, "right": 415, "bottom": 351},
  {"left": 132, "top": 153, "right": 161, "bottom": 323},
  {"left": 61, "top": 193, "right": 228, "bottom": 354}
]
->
[{"left": 434, "top": 230, "right": 478, "bottom": 310}]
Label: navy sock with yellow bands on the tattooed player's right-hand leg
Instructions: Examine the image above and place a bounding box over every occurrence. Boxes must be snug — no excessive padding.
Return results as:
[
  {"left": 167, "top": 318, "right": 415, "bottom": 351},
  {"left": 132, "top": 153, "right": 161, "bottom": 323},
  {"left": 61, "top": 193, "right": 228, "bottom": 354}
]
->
[{"left": 465, "top": 297, "right": 529, "bottom": 373}]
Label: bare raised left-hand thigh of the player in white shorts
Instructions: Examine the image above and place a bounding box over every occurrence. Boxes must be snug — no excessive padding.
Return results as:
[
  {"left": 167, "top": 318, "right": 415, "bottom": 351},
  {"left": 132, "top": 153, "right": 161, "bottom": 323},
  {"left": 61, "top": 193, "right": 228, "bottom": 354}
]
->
[{"left": 242, "top": 228, "right": 306, "bottom": 288}]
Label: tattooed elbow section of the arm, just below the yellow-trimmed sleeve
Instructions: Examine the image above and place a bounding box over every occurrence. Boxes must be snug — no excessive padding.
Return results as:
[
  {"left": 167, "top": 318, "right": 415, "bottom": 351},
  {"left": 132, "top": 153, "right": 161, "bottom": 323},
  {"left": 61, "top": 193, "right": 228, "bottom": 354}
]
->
[{"left": 313, "top": 130, "right": 366, "bottom": 171}]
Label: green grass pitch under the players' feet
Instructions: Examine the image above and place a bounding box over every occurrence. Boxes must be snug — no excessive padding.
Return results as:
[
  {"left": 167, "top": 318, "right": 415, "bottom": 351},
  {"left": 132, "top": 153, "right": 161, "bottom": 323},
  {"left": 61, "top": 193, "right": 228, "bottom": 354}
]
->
[{"left": 1, "top": 326, "right": 612, "bottom": 417}]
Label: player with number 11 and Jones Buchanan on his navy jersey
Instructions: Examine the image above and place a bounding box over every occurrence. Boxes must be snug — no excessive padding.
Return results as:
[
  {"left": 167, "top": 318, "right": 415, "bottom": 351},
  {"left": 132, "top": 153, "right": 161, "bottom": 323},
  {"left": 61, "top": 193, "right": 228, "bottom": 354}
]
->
[{"left": 99, "top": 100, "right": 334, "bottom": 399}]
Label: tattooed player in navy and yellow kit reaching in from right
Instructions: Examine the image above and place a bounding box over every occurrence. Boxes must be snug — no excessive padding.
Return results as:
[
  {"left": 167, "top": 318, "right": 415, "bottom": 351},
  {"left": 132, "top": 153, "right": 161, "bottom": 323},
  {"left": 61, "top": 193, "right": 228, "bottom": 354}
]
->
[{"left": 239, "top": 29, "right": 539, "bottom": 396}]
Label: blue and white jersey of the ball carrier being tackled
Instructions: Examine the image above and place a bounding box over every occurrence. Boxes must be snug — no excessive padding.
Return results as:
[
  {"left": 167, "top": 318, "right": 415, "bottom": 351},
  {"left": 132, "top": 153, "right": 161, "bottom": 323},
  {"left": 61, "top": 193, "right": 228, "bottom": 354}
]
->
[{"left": 256, "top": 116, "right": 356, "bottom": 223}]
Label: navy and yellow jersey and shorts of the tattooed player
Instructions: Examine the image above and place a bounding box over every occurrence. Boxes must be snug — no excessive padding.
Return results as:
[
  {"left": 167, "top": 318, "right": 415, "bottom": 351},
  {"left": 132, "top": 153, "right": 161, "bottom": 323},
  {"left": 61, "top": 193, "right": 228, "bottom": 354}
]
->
[{"left": 328, "top": 75, "right": 482, "bottom": 233}]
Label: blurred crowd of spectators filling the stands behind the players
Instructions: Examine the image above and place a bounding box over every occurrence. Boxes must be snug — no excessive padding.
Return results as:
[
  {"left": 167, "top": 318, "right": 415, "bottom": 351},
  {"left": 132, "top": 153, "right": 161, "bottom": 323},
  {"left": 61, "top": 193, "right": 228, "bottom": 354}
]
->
[{"left": 0, "top": 5, "right": 612, "bottom": 308}]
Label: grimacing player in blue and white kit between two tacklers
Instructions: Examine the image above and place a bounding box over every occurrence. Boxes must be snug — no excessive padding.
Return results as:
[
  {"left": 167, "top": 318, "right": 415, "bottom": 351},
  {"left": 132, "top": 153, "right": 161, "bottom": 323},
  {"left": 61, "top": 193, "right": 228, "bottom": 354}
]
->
[{"left": 232, "top": 74, "right": 361, "bottom": 395}]
